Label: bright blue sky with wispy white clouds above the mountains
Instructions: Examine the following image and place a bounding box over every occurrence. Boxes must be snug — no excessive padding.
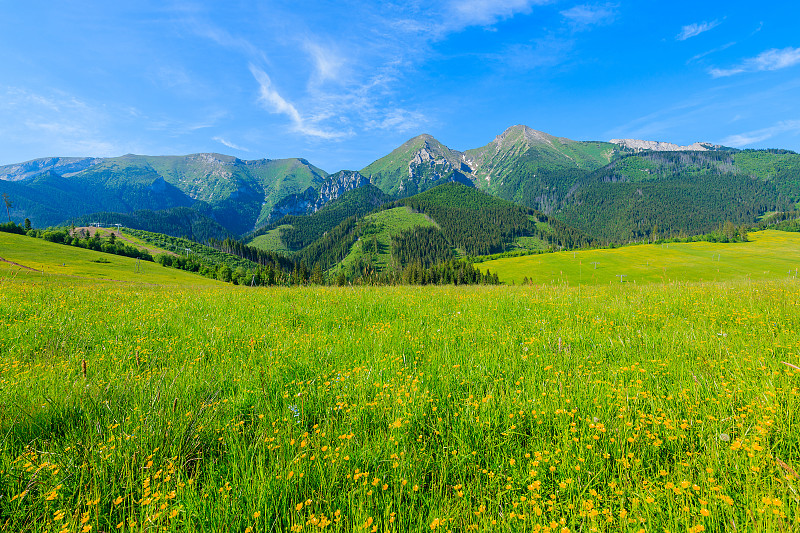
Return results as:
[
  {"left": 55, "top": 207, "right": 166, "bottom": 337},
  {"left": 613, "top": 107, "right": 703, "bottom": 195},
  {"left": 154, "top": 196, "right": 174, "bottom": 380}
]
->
[{"left": 0, "top": 0, "right": 800, "bottom": 172}]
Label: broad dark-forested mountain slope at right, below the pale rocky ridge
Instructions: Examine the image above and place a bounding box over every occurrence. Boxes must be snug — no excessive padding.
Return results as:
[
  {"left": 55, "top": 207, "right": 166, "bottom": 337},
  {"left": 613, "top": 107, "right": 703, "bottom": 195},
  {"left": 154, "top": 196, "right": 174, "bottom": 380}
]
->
[{"left": 555, "top": 152, "right": 800, "bottom": 242}]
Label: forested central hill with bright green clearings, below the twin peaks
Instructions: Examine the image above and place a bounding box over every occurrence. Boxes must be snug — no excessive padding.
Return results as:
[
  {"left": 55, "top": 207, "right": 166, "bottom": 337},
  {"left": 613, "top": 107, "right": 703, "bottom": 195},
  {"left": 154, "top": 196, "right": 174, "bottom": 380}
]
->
[{"left": 296, "top": 183, "right": 591, "bottom": 272}]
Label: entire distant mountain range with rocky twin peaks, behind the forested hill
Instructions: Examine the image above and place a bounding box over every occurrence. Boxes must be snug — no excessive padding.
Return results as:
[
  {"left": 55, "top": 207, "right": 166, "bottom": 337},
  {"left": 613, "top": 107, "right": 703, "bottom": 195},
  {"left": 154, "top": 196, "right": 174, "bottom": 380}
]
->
[{"left": 0, "top": 125, "right": 800, "bottom": 242}]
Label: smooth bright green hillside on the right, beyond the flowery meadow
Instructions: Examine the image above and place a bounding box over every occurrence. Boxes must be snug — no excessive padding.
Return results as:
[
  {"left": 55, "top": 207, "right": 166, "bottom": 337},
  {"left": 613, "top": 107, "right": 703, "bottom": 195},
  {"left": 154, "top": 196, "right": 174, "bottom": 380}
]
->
[{"left": 478, "top": 230, "right": 800, "bottom": 286}]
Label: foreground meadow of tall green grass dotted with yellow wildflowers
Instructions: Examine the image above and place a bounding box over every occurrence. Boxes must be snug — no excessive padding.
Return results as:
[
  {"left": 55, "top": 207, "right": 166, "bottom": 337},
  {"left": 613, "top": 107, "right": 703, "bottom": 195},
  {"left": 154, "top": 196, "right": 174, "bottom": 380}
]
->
[{"left": 0, "top": 264, "right": 800, "bottom": 533}]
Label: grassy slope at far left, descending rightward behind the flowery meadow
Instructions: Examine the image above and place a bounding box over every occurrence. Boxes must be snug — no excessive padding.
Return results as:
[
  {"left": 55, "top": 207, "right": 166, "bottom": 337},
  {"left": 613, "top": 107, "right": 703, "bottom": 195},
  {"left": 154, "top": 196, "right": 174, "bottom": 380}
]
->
[{"left": 0, "top": 232, "right": 221, "bottom": 286}]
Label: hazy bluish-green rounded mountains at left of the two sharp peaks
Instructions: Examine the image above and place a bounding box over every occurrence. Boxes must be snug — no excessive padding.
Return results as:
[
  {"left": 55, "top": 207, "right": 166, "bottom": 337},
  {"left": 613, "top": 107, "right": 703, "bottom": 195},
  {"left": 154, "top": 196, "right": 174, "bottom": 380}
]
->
[{"left": 0, "top": 154, "right": 327, "bottom": 234}]
